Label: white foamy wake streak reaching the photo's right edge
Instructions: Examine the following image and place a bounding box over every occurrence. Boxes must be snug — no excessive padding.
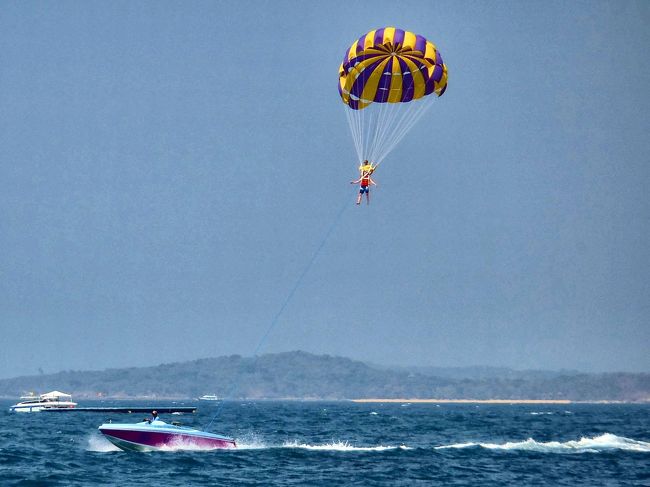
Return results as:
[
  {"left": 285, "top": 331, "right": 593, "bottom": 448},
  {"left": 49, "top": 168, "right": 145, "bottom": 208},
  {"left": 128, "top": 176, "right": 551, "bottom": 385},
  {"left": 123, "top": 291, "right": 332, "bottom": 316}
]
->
[{"left": 435, "top": 433, "right": 650, "bottom": 453}]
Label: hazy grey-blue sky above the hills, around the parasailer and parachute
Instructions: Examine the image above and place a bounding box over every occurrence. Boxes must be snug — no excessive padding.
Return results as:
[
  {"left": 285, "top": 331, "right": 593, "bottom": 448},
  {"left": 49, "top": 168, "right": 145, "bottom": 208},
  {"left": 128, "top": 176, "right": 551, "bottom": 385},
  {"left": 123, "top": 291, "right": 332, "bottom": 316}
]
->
[{"left": 0, "top": 0, "right": 650, "bottom": 377}]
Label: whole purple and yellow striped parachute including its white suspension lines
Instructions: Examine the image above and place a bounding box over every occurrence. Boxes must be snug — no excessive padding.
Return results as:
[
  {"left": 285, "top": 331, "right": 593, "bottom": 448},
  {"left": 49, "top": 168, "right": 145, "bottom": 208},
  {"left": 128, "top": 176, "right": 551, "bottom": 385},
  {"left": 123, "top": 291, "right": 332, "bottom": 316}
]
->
[{"left": 338, "top": 27, "right": 447, "bottom": 167}]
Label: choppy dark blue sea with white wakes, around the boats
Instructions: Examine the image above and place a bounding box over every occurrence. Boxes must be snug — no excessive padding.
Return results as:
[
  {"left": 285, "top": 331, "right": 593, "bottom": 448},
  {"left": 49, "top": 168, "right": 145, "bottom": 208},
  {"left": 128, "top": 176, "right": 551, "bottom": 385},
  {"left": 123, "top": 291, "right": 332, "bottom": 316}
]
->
[{"left": 0, "top": 401, "right": 650, "bottom": 486}]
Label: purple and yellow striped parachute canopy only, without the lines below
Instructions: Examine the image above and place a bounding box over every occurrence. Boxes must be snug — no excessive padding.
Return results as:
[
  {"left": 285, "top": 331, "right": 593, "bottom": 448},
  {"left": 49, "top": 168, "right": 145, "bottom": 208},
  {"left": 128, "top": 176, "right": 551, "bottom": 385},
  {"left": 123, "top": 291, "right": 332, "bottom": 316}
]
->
[{"left": 339, "top": 27, "right": 447, "bottom": 110}]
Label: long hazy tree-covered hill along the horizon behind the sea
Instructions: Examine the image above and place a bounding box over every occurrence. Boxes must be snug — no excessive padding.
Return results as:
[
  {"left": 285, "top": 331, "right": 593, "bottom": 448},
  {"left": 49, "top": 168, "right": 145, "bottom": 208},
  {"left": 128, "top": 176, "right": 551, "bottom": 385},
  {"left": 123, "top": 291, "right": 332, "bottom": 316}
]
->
[{"left": 0, "top": 352, "right": 650, "bottom": 402}]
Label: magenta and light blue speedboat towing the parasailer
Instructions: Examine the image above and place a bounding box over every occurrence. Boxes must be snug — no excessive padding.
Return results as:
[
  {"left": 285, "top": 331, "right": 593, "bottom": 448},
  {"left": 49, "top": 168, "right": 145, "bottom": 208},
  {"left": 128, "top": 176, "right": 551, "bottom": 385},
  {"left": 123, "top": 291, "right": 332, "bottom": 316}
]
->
[{"left": 99, "top": 419, "right": 237, "bottom": 451}]
